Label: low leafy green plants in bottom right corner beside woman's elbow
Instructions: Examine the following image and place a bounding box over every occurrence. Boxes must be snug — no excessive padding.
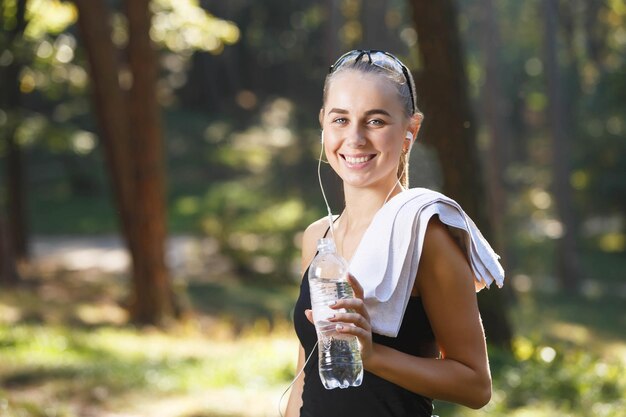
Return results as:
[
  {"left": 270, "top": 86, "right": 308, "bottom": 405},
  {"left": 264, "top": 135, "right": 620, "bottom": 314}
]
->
[{"left": 435, "top": 337, "right": 626, "bottom": 417}]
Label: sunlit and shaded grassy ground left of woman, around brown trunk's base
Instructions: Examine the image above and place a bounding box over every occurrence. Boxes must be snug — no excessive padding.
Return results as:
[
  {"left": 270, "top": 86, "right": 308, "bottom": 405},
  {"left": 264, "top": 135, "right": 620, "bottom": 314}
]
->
[{"left": 0, "top": 272, "right": 297, "bottom": 417}]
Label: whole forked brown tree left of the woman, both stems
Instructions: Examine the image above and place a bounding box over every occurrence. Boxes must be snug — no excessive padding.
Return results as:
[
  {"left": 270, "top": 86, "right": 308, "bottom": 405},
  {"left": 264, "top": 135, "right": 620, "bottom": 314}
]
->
[{"left": 75, "top": 0, "right": 175, "bottom": 324}]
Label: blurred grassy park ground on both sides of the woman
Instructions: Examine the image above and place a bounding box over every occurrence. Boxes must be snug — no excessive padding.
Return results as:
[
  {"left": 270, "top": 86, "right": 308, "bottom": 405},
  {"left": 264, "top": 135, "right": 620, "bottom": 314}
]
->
[{"left": 0, "top": 236, "right": 626, "bottom": 417}]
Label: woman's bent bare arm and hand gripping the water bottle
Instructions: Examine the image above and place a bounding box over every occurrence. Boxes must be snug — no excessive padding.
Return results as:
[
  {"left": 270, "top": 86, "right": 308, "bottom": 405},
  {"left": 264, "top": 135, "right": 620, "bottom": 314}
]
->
[{"left": 326, "top": 219, "right": 491, "bottom": 408}]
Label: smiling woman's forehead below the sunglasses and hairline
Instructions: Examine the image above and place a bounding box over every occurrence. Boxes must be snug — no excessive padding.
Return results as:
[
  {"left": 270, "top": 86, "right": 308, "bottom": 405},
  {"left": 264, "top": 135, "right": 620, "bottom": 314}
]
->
[{"left": 324, "top": 69, "right": 403, "bottom": 112}]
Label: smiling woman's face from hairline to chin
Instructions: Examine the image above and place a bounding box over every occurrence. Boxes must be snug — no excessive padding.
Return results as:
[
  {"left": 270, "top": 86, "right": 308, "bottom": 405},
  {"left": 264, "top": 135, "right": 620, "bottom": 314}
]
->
[{"left": 320, "top": 70, "right": 409, "bottom": 188}]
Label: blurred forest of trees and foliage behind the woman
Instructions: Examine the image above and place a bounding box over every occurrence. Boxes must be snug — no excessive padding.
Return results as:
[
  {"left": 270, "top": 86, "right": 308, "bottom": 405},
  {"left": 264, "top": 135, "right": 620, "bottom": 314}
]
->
[{"left": 0, "top": 0, "right": 626, "bottom": 416}]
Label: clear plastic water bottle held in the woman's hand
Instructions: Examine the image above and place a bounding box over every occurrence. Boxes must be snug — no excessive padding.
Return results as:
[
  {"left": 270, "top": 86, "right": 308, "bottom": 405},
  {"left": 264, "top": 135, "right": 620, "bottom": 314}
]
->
[{"left": 309, "top": 239, "right": 363, "bottom": 389}]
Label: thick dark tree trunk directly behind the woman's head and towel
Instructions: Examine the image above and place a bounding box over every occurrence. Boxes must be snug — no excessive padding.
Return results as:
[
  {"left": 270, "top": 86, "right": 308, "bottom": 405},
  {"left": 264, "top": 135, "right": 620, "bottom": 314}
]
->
[{"left": 412, "top": 0, "right": 511, "bottom": 348}]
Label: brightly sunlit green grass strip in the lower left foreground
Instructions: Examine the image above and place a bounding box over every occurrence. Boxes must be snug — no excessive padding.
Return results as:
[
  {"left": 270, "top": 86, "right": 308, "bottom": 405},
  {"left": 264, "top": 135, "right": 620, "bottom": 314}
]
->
[{"left": 0, "top": 325, "right": 296, "bottom": 416}]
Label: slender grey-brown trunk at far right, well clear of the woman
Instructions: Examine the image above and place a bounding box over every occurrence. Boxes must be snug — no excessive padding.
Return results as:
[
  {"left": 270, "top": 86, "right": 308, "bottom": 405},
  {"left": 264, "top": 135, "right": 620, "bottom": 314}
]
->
[{"left": 542, "top": 0, "right": 580, "bottom": 292}]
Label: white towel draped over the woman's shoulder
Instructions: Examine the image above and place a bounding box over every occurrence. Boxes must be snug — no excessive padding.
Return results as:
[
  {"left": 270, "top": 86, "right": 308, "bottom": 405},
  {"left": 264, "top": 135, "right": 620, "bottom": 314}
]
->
[{"left": 349, "top": 188, "right": 504, "bottom": 337}]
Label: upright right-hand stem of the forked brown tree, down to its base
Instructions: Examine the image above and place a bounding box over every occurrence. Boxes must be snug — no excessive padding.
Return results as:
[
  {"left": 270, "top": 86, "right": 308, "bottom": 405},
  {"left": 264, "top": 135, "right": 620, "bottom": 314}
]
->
[{"left": 126, "top": 0, "right": 174, "bottom": 323}]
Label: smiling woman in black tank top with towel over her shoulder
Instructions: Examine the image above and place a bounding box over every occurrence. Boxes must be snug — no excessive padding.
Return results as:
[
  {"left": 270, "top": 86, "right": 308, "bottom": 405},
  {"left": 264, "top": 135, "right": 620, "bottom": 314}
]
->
[{"left": 287, "top": 50, "right": 502, "bottom": 417}]
